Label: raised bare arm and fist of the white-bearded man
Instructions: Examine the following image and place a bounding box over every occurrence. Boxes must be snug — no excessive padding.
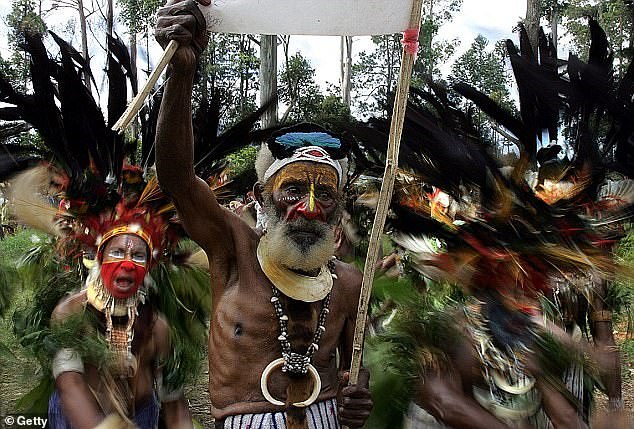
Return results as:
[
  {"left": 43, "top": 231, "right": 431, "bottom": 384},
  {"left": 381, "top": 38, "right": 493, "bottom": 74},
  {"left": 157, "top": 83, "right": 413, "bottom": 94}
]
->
[{"left": 156, "top": 0, "right": 230, "bottom": 252}]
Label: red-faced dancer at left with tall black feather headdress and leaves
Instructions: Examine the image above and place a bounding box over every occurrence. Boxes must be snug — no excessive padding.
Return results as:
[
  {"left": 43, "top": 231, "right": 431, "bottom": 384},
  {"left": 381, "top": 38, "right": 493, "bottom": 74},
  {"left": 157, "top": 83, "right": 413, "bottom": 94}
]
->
[{"left": 0, "top": 34, "right": 206, "bottom": 429}]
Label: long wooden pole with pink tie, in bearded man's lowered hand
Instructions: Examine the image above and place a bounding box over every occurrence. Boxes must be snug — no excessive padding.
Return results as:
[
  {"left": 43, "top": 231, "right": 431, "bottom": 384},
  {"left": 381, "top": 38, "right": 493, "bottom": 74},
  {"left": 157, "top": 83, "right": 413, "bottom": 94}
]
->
[{"left": 350, "top": 0, "right": 423, "bottom": 398}]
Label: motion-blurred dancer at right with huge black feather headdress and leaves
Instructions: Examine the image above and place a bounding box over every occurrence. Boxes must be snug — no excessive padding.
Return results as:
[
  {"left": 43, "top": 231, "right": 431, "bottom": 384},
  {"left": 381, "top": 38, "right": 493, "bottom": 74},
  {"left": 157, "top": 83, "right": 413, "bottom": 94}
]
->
[{"left": 354, "top": 18, "right": 634, "bottom": 429}]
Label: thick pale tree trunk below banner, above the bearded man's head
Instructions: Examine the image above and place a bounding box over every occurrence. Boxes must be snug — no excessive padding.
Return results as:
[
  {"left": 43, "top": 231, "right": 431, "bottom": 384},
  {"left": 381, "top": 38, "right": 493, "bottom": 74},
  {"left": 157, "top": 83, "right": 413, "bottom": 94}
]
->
[{"left": 260, "top": 35, "right": 277, "bottom": 128}]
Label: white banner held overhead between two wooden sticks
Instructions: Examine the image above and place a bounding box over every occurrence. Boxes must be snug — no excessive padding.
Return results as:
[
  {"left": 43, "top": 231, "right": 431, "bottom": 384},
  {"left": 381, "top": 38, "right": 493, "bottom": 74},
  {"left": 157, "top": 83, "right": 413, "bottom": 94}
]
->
[{"left": 200, "top": 0, "right": 412, "bottom": 36}]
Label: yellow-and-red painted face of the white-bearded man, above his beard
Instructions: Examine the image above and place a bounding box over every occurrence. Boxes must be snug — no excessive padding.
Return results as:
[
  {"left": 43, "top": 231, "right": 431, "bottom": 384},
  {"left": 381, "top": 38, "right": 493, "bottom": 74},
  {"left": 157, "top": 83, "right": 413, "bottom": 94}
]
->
[{"left": 271, "top": 162, "right": 338, "bottom": 223}]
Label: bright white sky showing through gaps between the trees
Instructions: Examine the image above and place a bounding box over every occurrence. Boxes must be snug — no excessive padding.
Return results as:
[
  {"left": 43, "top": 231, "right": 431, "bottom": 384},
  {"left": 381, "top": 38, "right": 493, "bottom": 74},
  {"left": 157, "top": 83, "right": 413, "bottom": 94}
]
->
[{"left": 0, "top": 0, "right": 526, "bottom": 104}]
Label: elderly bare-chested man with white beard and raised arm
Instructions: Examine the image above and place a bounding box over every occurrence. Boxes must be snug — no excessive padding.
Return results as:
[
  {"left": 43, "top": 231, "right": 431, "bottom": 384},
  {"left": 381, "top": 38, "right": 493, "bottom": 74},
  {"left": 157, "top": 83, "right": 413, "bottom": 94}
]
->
[{"left": 156, "top": 4, "right": 372, "bottom": 429}]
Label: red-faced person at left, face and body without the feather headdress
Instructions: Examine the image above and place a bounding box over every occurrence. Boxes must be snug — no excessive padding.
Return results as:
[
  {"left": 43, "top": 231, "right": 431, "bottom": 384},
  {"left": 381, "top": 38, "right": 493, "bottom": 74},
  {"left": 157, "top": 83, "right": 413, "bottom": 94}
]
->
[{"left": 49, "top": 225, "right": 192, "bottom": 429}]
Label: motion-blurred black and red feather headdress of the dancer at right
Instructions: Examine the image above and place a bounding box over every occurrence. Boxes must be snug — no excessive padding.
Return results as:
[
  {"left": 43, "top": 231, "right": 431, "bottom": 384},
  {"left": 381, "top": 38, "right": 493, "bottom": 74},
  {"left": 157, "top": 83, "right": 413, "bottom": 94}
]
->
[{"left": 354, "top": 21, "right": 634, "bottom": 294}]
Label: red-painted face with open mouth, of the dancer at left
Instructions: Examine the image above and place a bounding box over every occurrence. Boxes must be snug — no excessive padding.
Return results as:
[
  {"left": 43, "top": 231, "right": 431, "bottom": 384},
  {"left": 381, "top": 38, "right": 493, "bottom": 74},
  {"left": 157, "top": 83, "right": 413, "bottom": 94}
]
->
[{"left": 101, "top": 234, "right": 149, "bottom": 298}]
